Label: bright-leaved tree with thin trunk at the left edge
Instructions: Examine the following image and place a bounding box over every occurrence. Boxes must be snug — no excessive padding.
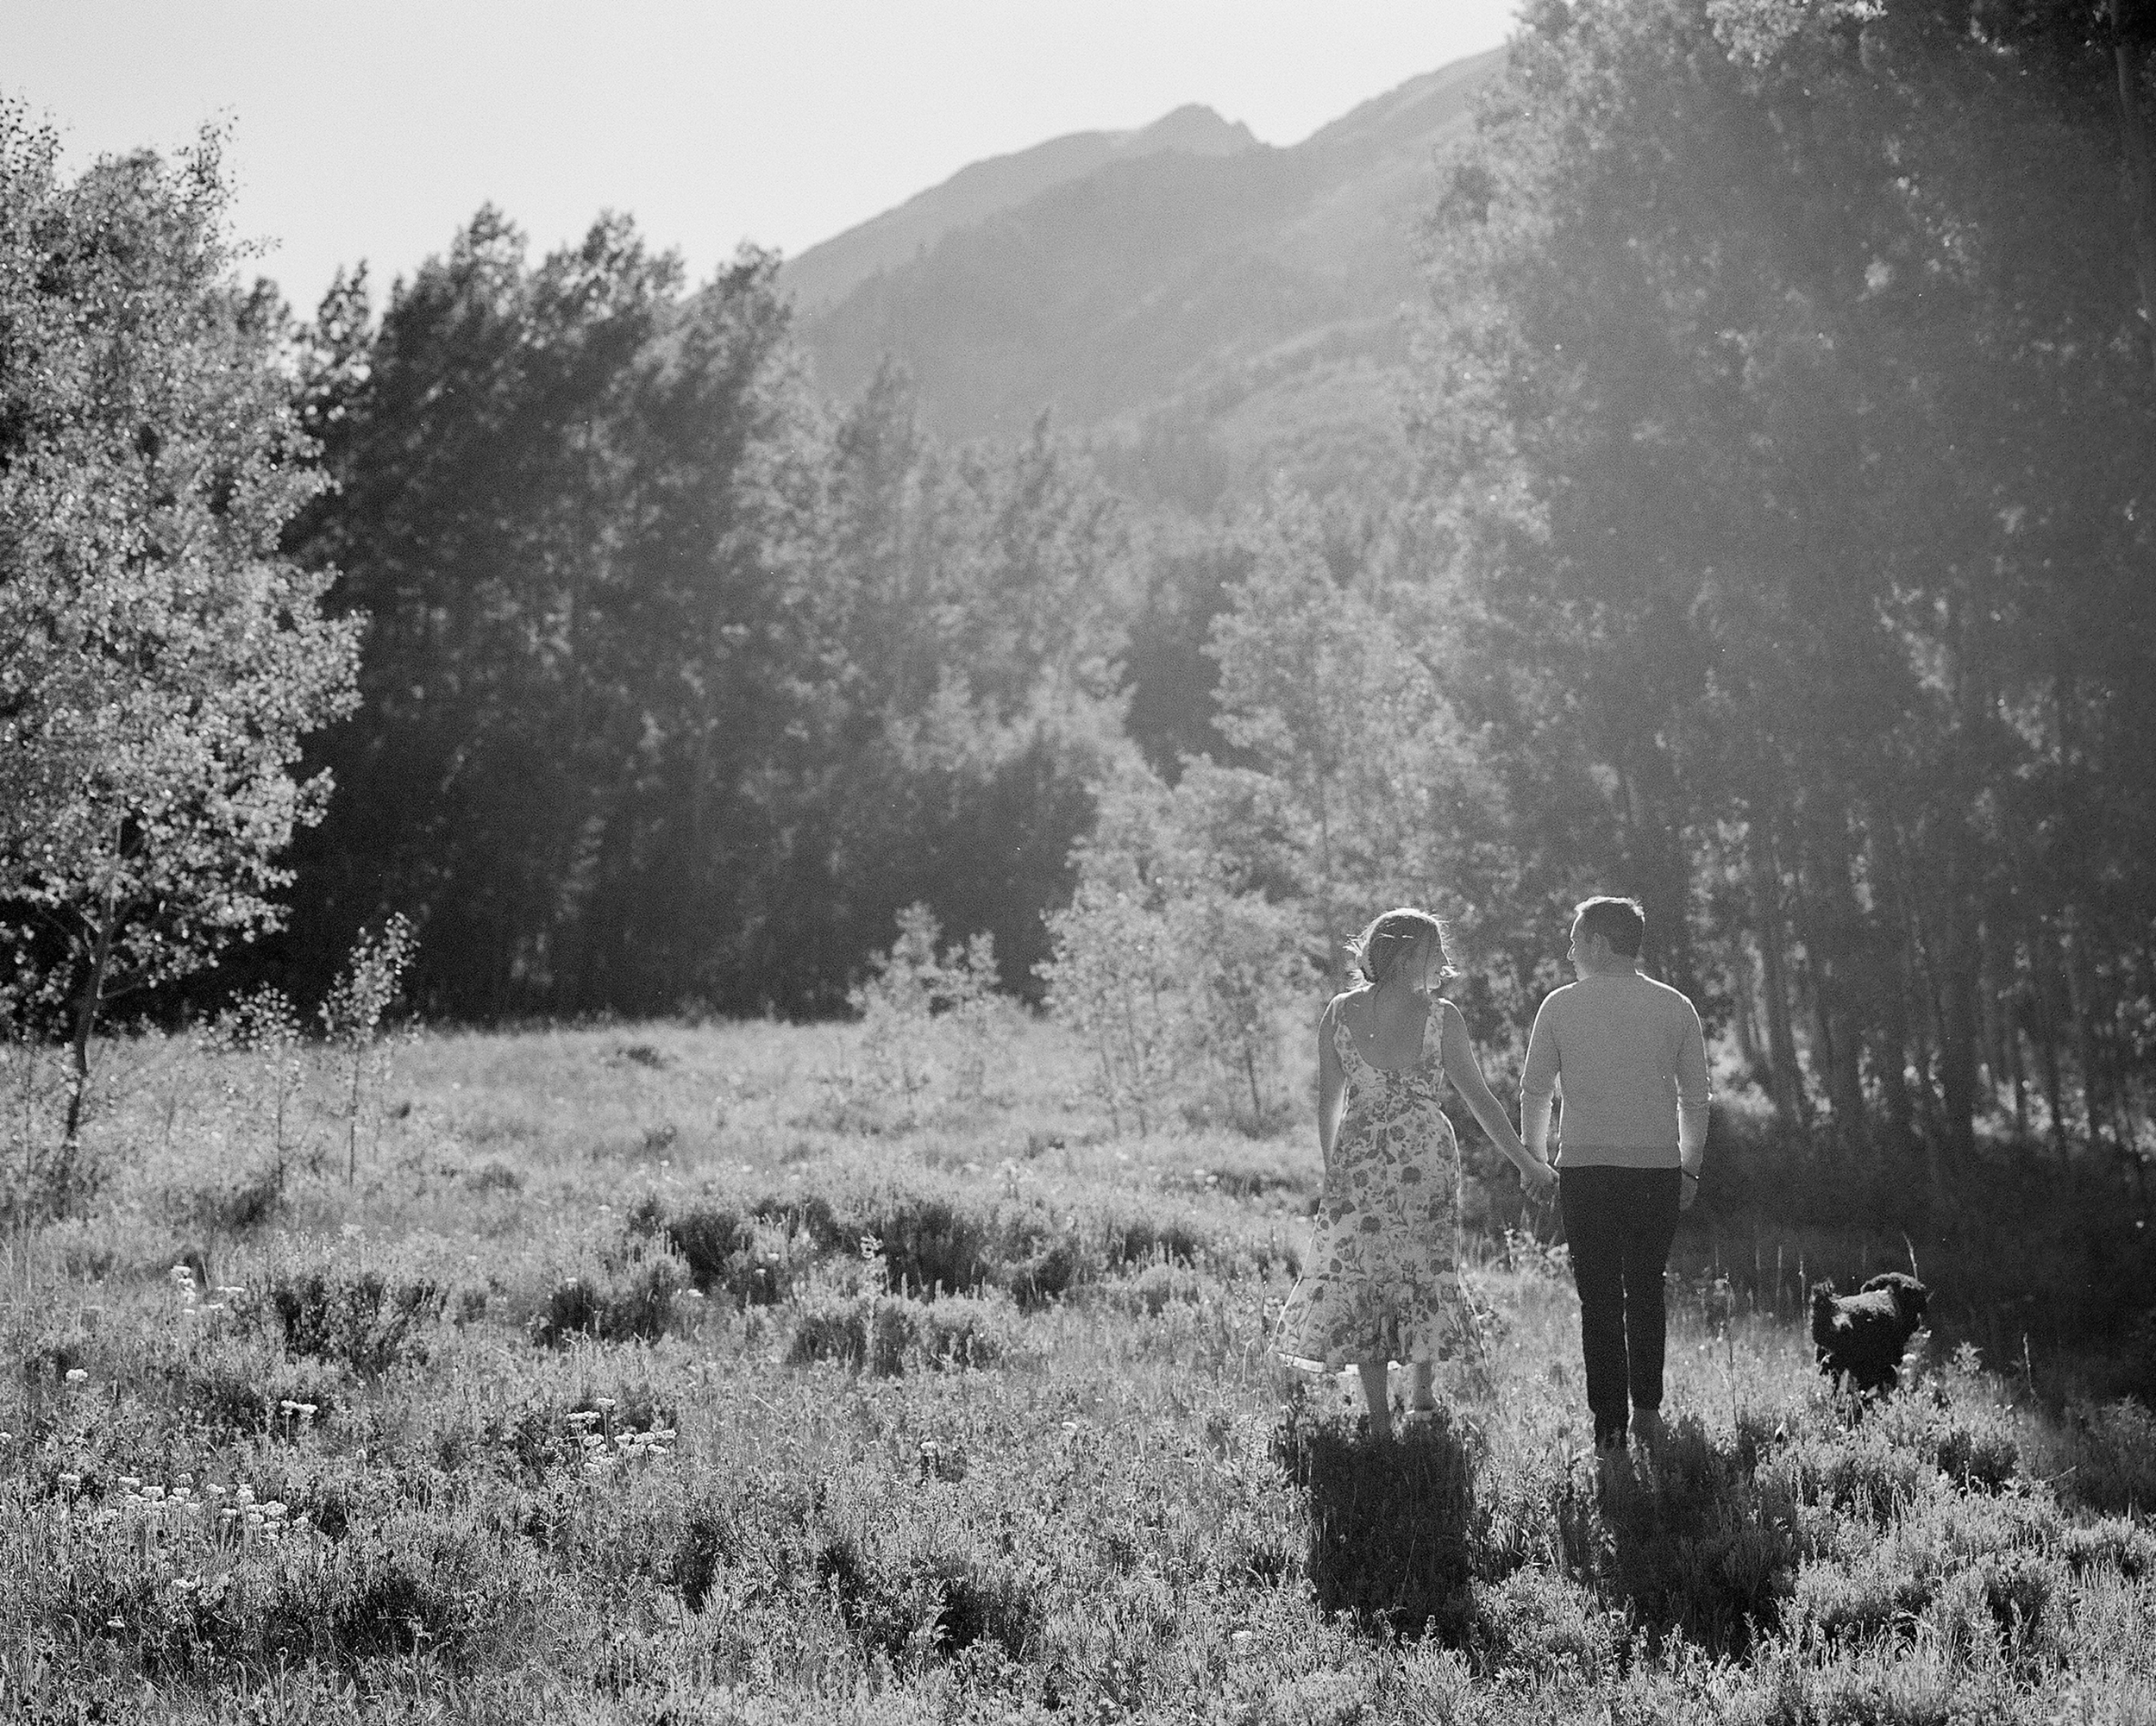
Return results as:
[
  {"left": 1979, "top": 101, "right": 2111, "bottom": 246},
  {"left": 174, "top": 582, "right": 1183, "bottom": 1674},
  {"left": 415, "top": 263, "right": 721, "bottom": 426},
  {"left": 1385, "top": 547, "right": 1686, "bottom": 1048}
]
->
[{"left": 0, "top": 104, "right": 358, "bottom": 1139}]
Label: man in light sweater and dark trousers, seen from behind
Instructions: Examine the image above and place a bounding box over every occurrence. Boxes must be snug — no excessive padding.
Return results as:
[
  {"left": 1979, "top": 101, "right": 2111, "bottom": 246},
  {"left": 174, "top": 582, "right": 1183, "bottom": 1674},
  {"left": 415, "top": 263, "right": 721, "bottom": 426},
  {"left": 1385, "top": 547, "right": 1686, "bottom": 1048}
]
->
[{"left": 1520, "top": 898, "right": 1708, "bottom": 1450}]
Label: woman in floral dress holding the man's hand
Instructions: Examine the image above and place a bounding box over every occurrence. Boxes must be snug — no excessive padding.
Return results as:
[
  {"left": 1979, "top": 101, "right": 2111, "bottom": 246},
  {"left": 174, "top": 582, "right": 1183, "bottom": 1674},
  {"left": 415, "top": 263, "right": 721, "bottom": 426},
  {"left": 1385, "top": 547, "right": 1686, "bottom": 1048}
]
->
[{"left": 1276, "top": 908, "right": 1557, "bottom": 1437}]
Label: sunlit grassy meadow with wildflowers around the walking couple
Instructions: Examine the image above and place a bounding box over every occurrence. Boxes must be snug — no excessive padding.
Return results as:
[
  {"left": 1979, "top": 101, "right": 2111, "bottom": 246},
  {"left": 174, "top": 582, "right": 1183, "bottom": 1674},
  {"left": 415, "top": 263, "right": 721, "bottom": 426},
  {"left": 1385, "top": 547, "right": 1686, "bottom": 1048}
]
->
[{"left": 0, "top": 1010, "right": 2156, "bottom": 1726}]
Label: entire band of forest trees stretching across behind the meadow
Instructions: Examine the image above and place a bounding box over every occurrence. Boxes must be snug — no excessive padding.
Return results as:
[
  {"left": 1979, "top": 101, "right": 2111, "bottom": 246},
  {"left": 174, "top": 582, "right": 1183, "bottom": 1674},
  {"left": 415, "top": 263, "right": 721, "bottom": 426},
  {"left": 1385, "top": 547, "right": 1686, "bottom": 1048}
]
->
[{"left": 0, "top": 0, "right": 2156, "bottom": 1178}]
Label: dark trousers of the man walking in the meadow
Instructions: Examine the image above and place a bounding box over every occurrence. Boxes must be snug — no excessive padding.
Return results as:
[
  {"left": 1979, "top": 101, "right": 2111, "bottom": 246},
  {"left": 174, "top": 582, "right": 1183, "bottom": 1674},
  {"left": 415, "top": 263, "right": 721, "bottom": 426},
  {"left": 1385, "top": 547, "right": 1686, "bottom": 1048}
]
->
[{"left": 1557, "top": 1165, "right": 1677, "bottom": 1443}]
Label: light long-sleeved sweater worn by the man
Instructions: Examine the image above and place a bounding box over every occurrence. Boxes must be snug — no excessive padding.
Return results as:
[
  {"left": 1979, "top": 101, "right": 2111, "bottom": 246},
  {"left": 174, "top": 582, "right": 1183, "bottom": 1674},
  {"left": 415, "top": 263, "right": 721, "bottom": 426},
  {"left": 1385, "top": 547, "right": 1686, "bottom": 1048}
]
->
[{"left": 1520, "top": 971, "right": 1708, "bottom": 1174}]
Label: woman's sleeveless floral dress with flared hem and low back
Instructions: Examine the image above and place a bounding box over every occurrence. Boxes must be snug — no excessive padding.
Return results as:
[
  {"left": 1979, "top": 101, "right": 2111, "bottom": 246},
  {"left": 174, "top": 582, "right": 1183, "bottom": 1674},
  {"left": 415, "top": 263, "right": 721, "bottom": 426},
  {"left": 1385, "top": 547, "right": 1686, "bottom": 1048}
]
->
[{"left": 1275, "top": 1001, "right": 1473, "bottom": 1372}]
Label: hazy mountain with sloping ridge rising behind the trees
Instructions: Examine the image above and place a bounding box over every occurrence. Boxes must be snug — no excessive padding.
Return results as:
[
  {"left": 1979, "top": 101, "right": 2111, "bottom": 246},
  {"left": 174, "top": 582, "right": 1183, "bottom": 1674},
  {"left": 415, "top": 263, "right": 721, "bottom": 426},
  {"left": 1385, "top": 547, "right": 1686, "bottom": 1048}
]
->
[{"left": 783, "top": 50, "right": 1503, "bottom": 500}]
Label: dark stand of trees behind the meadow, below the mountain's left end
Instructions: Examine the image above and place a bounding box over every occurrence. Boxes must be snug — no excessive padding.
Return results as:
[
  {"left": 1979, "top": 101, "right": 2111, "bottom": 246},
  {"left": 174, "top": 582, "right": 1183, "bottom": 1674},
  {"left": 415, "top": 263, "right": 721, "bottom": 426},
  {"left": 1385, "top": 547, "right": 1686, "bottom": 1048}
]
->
[{"left": 263, "top": 256, "right": 1125, "bottom": 1019}]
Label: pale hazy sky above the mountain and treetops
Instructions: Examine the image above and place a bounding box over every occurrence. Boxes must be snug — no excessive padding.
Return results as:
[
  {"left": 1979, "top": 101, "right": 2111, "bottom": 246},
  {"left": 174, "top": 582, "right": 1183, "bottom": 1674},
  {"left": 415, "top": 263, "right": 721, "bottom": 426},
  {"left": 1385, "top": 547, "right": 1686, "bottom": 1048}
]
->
[{"left": 0, "top": 0, "right": 1516, "bottom": 309}]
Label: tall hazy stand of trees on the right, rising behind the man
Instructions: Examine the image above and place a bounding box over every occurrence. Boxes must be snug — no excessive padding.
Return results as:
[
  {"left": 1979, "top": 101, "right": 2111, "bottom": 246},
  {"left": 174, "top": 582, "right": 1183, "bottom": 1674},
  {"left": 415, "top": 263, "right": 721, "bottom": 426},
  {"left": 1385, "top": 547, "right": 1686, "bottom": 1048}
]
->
[{"left": 1419, "top": 0, "right": 2156, "bottom": 1191}]
